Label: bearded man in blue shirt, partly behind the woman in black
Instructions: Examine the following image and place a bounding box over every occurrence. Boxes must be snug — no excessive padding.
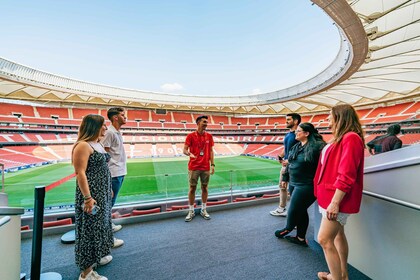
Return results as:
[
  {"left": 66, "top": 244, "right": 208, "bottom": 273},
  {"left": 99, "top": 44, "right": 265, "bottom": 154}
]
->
[{"left": 270, "top": 113, "right": 301, "bottom": 217}]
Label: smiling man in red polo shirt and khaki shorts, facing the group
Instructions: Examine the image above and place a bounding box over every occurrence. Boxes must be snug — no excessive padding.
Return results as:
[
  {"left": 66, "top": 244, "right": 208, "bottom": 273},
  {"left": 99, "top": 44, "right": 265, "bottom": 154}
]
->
[{"left": 184, "top": 116, "right": 215, "bottom": 222}]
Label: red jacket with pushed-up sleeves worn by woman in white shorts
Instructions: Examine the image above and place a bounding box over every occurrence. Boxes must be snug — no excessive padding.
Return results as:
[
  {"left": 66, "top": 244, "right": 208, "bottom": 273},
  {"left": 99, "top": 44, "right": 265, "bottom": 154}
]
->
[{"left": 314, "top": 132, "right": 365, "bottom": 214}]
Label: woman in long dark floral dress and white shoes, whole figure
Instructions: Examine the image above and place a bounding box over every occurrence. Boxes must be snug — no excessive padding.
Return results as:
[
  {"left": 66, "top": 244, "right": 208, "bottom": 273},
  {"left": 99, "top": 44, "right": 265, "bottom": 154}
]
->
[{"left": 72, "top": 115, "right": 114, "bottom": 280}]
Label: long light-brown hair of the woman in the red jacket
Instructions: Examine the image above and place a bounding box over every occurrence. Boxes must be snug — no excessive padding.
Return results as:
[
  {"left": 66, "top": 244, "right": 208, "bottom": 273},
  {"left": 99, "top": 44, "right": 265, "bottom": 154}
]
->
[{"left": 331, "top": 104, "right": 365, "bottom": 144}]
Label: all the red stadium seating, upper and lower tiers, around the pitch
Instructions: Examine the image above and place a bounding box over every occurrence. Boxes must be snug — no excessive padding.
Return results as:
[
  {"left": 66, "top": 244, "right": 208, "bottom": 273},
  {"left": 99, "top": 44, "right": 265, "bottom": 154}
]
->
[{"left": 0, "top": 102, "right": 420, "bottom": 169}]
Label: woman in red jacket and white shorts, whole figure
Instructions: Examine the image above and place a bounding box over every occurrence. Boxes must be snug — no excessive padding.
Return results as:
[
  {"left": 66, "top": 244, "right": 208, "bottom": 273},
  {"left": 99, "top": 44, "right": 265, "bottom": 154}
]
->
[{"left": 314, "top": 104, "right": 365, "bottom": 280}]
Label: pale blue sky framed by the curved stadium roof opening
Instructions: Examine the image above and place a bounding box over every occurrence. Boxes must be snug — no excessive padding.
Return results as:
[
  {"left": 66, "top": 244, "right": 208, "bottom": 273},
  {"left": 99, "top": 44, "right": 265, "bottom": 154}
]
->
[{"left": 0, "top": 0, "right": 339, "bottom": 96}]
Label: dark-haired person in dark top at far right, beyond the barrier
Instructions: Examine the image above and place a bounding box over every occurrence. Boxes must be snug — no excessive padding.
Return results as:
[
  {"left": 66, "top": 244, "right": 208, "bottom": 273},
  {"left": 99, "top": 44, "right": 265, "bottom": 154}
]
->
[{"left": 366, "top": 124, "right": 402, "bottom": 155}]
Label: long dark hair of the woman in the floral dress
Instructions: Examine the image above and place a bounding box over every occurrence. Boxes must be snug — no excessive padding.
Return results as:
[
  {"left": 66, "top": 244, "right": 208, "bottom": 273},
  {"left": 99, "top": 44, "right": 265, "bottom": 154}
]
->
[{"left": 71, "top": 114, "right": 105, "bottom": 162}]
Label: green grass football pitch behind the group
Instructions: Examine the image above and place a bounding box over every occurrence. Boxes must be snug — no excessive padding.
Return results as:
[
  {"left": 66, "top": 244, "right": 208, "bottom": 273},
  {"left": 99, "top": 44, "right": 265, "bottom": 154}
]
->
[{"left": 5, "top": 156, "right": 280, "bottom": 209}]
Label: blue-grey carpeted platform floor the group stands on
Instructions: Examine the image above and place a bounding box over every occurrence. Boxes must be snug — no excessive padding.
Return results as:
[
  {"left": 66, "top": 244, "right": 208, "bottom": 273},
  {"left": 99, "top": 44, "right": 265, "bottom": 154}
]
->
[{"left": 22, "top": 203, "right": 370, "bottom": 280}]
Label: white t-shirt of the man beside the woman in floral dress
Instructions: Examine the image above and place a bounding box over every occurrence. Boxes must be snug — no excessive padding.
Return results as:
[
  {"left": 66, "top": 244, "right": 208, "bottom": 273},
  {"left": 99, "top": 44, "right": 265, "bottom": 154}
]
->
[{"left": 101, "top": 125, "right": 127, "bottom": 177}]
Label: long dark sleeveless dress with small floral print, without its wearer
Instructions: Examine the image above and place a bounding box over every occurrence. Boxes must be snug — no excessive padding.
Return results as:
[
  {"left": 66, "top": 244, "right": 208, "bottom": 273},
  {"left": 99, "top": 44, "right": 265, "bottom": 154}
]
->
[{"left": 75, "top": 149, "right": 114, "bottom": 270}]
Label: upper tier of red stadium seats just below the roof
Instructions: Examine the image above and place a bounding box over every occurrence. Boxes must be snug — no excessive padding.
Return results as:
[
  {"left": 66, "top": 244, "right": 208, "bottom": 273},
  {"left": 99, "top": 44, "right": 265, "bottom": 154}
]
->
[{"left": 0, "top": 102, "right": 420, "bottom": 130}]
